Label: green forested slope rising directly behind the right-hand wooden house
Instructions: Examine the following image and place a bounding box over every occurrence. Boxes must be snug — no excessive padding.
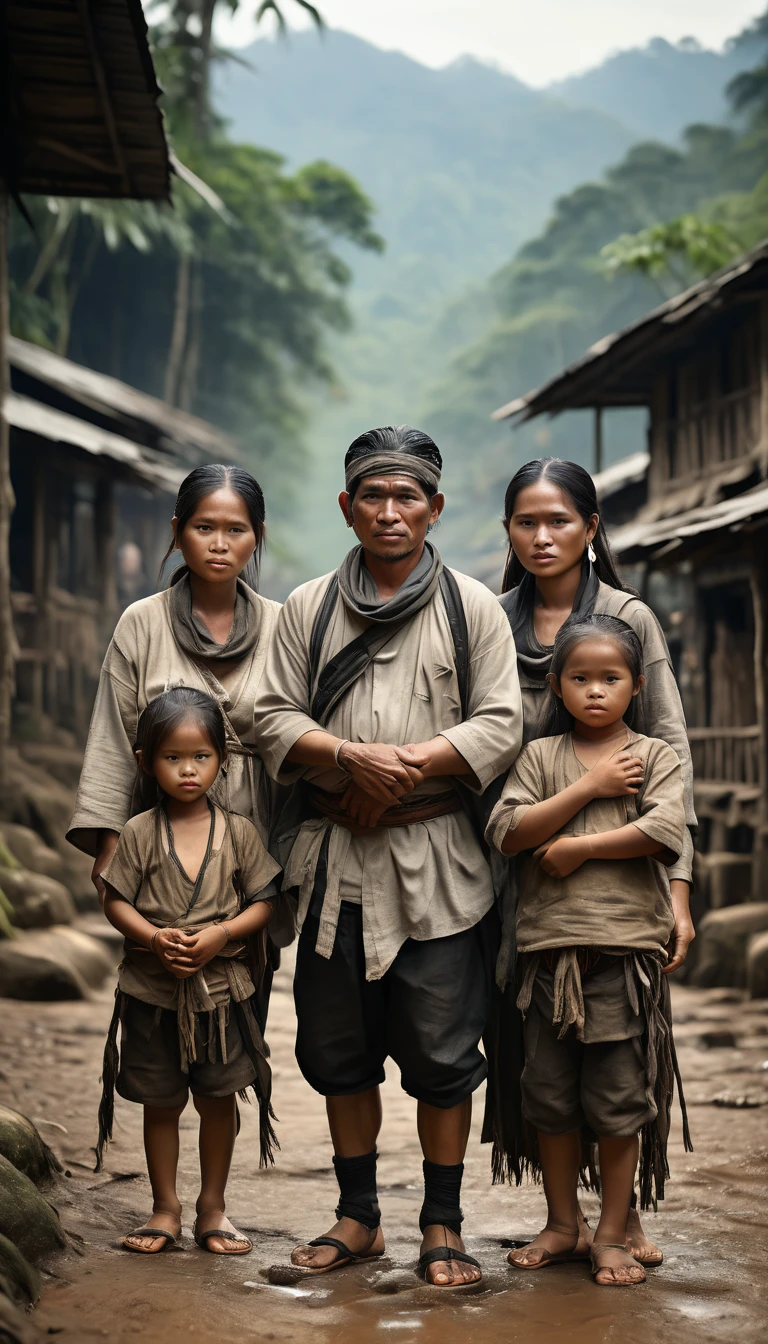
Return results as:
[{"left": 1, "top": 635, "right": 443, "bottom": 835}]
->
[{"left": 421, "top": 17, "right": 768, "bottom": 567}]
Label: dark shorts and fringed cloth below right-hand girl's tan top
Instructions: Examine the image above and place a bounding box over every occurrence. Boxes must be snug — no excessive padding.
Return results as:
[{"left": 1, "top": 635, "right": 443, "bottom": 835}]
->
[{"left": 483, "top": 948, "right": 691, "bottom": 1208}]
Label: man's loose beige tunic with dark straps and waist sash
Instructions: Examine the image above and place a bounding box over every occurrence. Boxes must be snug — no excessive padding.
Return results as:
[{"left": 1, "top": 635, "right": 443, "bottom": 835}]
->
[{"left": 254, "top": 561, "right": 522, "bottom": 980}]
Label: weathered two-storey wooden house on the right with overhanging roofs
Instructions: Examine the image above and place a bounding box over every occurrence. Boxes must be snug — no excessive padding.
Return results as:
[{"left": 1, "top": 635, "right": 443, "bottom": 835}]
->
[{"left": 495, "top": 243, "right": 768, "bottom": 906}]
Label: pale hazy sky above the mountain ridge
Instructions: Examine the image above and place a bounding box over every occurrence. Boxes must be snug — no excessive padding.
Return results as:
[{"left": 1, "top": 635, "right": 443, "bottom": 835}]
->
[{"left": 222, "top": 0, "right": 765, "bottom": 85}]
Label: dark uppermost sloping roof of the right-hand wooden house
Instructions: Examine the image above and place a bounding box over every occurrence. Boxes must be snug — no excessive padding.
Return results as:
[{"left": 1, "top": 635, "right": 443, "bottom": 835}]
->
[{"left": 492, "top": 242, "right": 768, "bottom": 423}]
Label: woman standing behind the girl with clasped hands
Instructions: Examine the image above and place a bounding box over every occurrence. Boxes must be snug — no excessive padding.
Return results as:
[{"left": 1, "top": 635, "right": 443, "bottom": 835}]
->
[{"left": 67, "top": 462, "right": 280, "bottom": 900}]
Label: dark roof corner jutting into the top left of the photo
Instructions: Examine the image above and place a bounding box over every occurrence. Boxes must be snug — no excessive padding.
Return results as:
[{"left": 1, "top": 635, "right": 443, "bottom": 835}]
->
[{"left": 0, "top": 0, "right": 169, "bottom": 200}]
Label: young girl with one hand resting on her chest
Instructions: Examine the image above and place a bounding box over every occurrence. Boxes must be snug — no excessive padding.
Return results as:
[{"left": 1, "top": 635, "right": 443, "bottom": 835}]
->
[{"left": 487, "top": 616, "right": 690, "bottom": 1285}]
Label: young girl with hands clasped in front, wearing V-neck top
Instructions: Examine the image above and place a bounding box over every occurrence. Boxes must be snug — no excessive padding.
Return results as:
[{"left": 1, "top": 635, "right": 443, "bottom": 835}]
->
[{"left": 97, "top": 687, "right": 280, "bottom": 1254}]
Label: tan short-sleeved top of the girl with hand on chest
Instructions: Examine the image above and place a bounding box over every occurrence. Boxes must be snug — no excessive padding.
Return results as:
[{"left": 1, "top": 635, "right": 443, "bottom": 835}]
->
[{"left": 486, "top": 732, "right": 687, "bottom": 952}]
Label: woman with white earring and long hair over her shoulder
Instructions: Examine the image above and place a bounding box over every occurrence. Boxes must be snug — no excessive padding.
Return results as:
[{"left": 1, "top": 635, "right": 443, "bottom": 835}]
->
[{"left": 486, "top": 457, "right": 695, "bottom": 1265}]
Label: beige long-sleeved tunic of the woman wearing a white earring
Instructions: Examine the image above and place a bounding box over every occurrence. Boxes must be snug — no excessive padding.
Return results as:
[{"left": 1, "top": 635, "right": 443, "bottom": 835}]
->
[{"left": 521, "top": 583, "right": 697, "bottom": 882}]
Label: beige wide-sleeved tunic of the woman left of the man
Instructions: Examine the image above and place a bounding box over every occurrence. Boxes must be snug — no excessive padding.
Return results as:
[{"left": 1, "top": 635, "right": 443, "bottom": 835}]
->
[{"left": 67, "top": 590, "right": 280, "bottom": 855}]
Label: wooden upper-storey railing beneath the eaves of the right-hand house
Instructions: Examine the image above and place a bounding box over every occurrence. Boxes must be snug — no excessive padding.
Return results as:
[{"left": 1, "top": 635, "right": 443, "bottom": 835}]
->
[{"left": 654, "top": 387, "right": 760, "bottom": 488}]
